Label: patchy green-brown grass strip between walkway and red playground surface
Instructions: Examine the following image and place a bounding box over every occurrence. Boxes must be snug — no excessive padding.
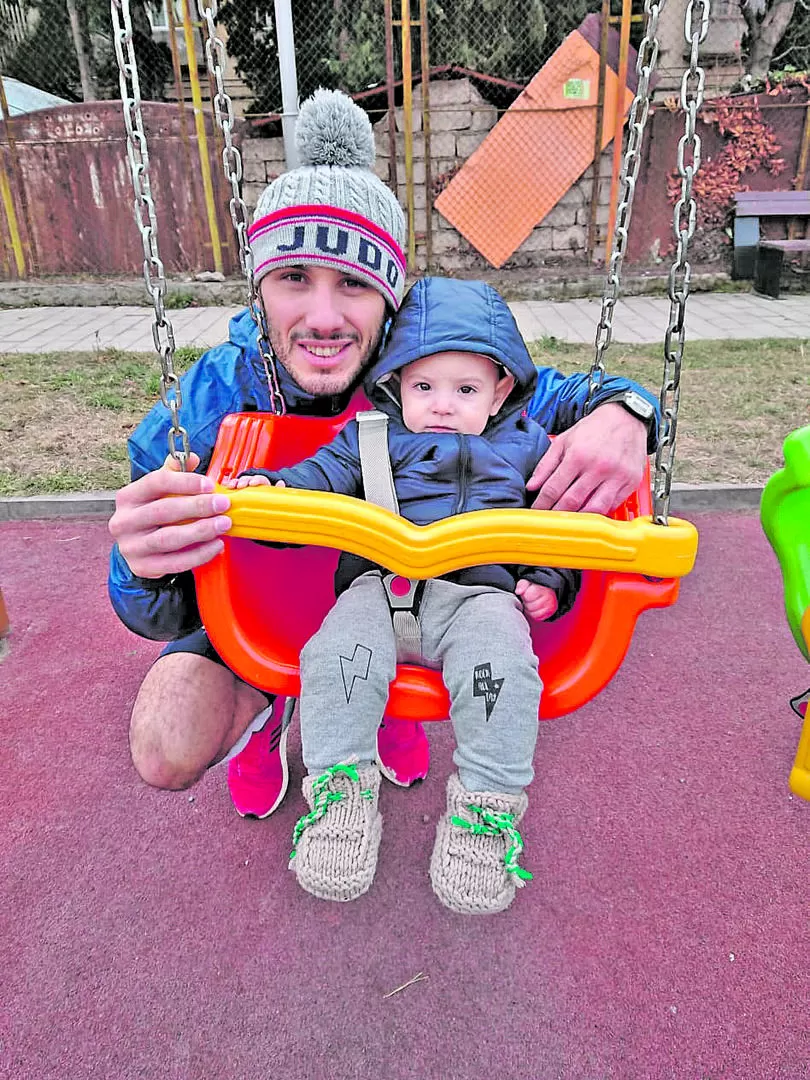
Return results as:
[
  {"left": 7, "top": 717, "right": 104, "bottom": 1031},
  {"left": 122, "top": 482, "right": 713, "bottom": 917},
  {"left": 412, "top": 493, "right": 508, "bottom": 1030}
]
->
[{"left": 0, "top": 338, "right": 810, "bottom": 496}]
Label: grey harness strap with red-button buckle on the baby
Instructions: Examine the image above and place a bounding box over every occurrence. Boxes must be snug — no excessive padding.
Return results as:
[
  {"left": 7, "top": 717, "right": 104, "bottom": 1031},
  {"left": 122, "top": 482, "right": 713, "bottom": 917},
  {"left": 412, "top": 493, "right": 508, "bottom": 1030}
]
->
[{"left": 355, "top": 409, "right": 422, "bottom": 663}]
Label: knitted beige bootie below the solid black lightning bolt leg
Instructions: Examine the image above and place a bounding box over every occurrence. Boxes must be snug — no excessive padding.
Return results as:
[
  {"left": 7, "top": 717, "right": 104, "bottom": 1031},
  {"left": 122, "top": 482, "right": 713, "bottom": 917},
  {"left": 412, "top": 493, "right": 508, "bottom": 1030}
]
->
[{"left": 430, "top": 772, "right": 531, "bottom": 915}]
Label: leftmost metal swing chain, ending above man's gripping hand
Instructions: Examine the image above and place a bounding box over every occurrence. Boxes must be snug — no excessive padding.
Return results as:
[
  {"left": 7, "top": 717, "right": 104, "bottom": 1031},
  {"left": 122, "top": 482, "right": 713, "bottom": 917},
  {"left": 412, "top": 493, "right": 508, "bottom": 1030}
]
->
[{"left": 110, "top": 0, "right": 190, "bottom": 460}]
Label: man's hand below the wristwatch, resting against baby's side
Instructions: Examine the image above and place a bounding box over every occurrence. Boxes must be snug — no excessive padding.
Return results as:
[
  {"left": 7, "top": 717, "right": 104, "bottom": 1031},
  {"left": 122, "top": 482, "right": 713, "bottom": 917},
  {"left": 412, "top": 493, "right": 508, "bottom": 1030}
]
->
[{"left": 526, "top": 402, "right": 647, "bottom": 514}]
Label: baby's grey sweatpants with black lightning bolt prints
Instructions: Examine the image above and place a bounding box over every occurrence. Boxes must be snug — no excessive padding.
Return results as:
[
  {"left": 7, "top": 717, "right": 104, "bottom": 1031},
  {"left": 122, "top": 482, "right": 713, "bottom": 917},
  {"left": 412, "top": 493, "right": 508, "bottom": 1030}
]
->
[{"left": 300, "top": 573, "right": 542, "bottom": 795}]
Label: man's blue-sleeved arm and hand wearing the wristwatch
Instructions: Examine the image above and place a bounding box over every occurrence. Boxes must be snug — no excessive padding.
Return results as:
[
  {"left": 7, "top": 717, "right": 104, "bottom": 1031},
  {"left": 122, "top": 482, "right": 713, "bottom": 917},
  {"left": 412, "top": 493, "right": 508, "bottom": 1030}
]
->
[{"left": 526, "top": 368, "right": 659, "bottom": 514}]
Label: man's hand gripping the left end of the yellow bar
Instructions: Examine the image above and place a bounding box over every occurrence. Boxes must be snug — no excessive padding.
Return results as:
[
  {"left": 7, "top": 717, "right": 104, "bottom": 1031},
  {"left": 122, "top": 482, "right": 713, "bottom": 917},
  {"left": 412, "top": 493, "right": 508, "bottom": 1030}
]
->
[{"left": 109, "top": 454, "right": 231, "bottom": 578}]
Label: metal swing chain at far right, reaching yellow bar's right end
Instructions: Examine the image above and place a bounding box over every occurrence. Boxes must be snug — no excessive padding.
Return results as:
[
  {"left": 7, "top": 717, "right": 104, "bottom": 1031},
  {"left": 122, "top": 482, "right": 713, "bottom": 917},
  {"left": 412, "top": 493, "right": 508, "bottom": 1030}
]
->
[{"left": 652, "top": 0, "right": 711, "bottom": 525}]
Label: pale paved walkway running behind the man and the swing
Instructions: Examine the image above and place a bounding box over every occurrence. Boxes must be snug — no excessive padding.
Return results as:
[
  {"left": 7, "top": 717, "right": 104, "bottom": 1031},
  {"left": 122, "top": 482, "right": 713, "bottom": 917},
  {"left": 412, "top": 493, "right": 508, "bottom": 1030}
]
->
[{"left": 0, "top": 293, "right": 810, "bottom": 352}]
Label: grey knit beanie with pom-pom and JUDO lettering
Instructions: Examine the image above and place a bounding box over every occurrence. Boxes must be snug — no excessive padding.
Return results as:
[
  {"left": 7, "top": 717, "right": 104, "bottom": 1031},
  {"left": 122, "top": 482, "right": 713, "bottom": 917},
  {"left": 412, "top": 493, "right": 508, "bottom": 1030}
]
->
[{"left": 247, "top": 90, "right": 406, "bottom": 310}]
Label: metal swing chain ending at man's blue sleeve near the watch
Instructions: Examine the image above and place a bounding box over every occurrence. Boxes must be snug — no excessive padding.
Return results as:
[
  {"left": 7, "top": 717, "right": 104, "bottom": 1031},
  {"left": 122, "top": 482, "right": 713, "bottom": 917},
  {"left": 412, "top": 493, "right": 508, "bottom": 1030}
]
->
[{"left": 585, "top": 0, "right": 663, "bottom": 413}]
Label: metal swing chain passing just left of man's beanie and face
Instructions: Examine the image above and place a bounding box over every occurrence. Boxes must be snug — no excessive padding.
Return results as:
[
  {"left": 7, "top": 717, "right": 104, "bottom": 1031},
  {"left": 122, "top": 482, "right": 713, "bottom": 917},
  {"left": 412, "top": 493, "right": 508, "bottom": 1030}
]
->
[{"left": 197, "top": 0, "right": 286, "bottom": 416}]
